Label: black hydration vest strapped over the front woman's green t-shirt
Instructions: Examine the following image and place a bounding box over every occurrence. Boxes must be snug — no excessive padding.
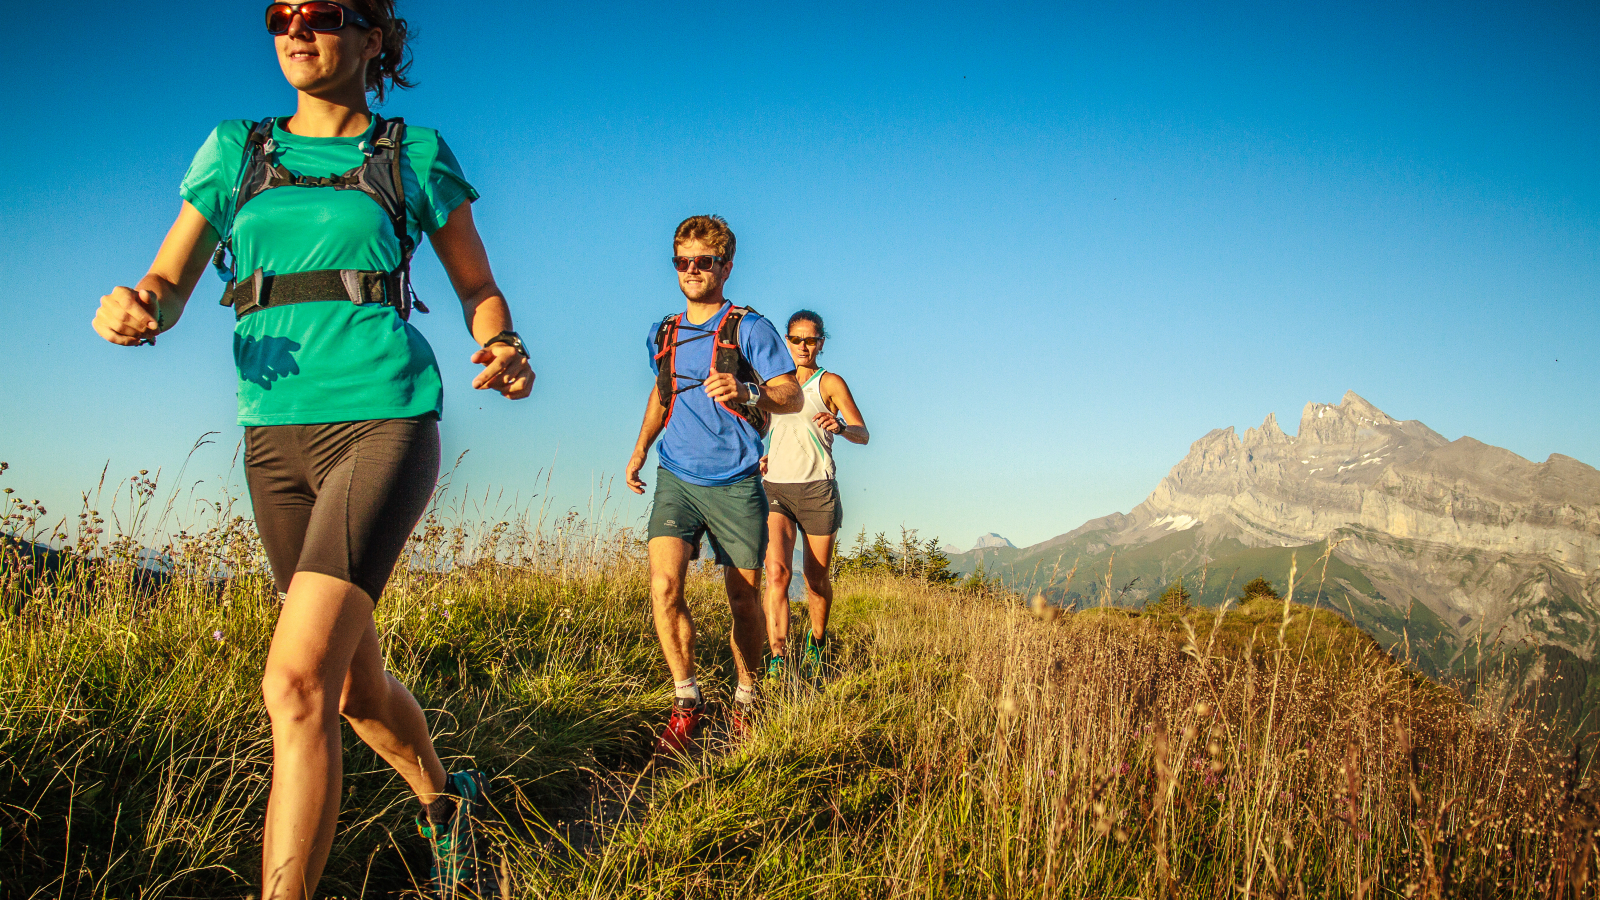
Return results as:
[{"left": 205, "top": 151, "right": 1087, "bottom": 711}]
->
[{"left": 211, "top": 115, "right": 427, "bottom": 319}]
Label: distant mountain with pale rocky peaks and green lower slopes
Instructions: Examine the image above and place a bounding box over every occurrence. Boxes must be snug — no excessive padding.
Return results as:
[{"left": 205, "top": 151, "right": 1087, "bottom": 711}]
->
[{"left": 954, "top": 392, "right": 1600, "bottom": 711}]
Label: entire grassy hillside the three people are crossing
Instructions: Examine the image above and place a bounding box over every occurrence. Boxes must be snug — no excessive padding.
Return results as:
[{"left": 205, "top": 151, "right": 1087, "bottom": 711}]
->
[{"left": 0, "top": 509, "right": 1600, "bottom": 900}]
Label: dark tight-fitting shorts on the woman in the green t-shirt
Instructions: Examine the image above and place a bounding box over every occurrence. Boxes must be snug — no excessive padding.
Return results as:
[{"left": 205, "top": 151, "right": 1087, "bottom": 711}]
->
[{"left": 245, "top": 415, "right": 438, "bottom": 602}]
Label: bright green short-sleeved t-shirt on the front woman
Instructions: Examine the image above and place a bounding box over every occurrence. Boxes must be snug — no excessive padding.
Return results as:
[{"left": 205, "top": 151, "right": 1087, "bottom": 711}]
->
[{"left": 179, "top": 117, "right": 478, "bottom": 426}]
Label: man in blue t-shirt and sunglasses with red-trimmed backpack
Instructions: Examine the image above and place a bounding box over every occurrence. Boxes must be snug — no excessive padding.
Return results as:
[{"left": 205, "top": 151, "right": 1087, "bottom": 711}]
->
[{"left": 627, "top": 216, "right": 803, "bottom": 753}]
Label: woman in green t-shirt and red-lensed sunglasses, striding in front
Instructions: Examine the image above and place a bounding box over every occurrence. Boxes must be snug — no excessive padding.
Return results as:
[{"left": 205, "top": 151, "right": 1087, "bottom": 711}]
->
[{"left": 94, "top": 0, "right": 534, "bottom": 900}]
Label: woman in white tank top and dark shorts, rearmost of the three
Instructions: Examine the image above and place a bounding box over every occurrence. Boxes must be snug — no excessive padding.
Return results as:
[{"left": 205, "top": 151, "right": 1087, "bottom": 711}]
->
[{"left": 762, "top": 309, "right": 870, "bottom": 682}]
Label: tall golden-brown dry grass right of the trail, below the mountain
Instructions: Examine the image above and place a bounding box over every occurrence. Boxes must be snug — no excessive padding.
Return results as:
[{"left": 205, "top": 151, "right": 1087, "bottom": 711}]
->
[{"left": 540, "top": 578, "right": 1595, "bottom": 898}]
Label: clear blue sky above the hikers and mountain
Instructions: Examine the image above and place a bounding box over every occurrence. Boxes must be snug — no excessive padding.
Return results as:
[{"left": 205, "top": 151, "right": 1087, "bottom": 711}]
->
[{"left": 0, "top": 0, "right": 1600, "bottom": 548}]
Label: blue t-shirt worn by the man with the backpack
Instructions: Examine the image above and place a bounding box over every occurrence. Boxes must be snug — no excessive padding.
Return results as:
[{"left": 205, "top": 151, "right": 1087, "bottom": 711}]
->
[{"left": 645, "top": 303, "right": 795, "bottom": 487}]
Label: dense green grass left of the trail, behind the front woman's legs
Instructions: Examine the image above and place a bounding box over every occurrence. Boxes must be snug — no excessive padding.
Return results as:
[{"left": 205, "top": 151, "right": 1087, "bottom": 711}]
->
[{"left": 0, "top": 538, "right": 681, "bottom": 897}]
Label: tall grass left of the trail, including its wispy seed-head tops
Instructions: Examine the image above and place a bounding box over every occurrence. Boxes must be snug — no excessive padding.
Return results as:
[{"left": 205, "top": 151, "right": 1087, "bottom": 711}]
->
[{"left": 0, "top": 458, "right": 739, "bottom": 900}]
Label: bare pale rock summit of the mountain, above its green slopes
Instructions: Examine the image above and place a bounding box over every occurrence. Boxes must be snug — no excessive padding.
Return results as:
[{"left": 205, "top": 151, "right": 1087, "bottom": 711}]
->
[{"left": 1110, "top": 391, "right": 1600, "bottom": 569}]
